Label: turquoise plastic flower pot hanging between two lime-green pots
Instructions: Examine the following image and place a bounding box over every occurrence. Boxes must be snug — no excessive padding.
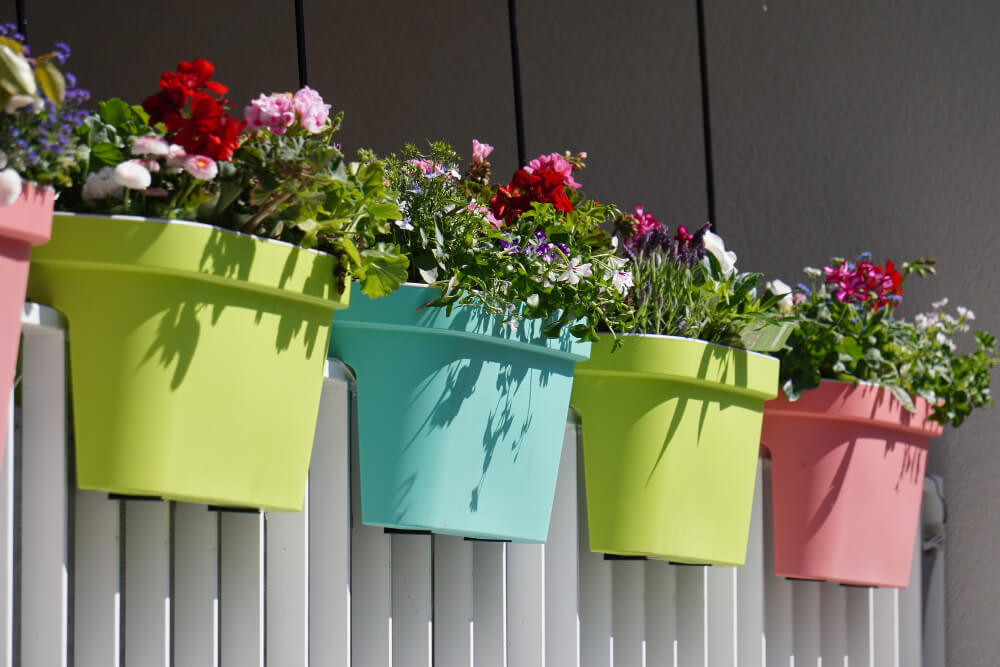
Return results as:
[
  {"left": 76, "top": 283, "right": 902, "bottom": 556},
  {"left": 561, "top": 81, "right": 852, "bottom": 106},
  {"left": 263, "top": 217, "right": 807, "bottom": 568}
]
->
[{"left": 330, "top": 285, "right": 590, "bottom": 542}]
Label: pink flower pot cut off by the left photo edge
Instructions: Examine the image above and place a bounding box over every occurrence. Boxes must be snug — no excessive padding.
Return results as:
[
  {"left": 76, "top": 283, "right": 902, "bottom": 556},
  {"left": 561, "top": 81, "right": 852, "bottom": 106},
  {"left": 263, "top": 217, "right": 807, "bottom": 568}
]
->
[{"left": 0, "top": 183, "right": 54, "bottom": 448}]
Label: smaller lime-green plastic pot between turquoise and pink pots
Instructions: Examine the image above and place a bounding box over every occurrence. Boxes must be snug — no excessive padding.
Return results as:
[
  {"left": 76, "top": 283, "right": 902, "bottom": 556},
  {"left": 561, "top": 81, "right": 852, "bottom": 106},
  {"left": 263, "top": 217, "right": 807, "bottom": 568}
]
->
[{"left": 571, "top": 335, "right": 778, "bottom": 565}]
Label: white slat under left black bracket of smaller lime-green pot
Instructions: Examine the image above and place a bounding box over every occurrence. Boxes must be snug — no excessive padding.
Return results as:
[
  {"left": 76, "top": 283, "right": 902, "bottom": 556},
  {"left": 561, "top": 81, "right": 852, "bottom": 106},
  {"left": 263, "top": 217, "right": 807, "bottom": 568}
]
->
[{"left": 605, "top": 560, "right": 646, "bottom": 667}]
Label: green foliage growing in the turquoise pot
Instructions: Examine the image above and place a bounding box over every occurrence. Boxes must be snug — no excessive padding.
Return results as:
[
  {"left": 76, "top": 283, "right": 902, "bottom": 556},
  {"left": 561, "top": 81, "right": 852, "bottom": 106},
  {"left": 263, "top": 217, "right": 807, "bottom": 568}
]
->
[{"left": 376, "top": 142, "right": 631, "bottom": 340}]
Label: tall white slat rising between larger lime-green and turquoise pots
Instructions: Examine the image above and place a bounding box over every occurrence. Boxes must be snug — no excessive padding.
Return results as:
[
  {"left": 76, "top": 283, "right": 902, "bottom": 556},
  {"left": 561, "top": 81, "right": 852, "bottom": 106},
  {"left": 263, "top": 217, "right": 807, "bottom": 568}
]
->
[{"left": 309, "top": 374, "right": 351, "bottom": 667}]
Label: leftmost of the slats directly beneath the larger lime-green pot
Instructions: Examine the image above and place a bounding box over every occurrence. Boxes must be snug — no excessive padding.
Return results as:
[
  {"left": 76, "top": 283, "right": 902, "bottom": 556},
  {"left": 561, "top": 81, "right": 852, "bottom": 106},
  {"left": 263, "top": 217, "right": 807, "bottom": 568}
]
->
[{"left": 74, "top": 490, "right": 122, "bottom": 667}]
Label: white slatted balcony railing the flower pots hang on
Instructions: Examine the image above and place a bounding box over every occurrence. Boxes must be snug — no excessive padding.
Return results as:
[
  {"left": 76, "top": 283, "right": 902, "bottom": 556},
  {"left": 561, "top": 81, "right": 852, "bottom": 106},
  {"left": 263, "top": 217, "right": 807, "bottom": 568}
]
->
[{"left": 0, "top": 304, "right": 922, "bottom": 667}]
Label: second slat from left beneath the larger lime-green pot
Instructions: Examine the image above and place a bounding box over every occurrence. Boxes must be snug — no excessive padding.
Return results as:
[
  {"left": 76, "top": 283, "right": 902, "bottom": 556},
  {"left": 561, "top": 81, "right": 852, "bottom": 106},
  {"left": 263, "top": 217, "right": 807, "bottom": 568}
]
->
[{"left": 124, "top": 500, "right": 170, "bottom": 667}]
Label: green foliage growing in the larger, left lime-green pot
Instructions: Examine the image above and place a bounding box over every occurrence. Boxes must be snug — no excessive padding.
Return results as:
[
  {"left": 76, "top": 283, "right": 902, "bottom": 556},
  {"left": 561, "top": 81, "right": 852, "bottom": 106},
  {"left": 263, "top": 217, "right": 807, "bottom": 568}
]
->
[{"left": 59, "top": 99, "right": 407, "bottom": 295}]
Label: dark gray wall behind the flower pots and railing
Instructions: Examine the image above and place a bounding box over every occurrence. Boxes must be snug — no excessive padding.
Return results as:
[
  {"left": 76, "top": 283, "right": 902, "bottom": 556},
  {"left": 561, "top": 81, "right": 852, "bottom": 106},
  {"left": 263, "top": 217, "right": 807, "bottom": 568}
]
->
[{"left": 15, "top": 0, "right": 1000, "bottom": 667}]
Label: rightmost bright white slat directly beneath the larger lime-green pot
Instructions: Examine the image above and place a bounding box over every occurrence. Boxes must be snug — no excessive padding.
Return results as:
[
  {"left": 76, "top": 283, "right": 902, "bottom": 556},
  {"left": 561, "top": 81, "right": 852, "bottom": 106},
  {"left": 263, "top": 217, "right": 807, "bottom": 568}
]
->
[{"left": 264, "top": 500, "right": 309, "bottom": 667}]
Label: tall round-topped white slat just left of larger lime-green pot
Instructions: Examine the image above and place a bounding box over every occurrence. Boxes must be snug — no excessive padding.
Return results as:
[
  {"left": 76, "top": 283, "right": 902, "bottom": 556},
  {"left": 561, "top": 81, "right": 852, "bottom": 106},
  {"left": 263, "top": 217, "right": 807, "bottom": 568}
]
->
[{"left": 18, "top": 316, "right": 69, "bottom": 665}]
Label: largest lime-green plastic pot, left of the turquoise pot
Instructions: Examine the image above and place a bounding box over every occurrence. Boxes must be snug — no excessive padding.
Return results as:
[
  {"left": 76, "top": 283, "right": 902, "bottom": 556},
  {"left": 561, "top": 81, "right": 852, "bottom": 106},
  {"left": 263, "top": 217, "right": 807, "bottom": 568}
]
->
[{"left": 28, "top": 214, "right": 349, "bottom": 511}]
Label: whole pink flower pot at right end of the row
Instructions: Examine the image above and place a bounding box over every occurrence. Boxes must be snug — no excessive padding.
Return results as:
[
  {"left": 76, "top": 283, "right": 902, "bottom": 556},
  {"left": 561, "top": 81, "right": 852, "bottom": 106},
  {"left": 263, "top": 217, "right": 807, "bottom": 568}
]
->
[{"left": 761, "top": 380, "right": 941, "bottom": 588}]
